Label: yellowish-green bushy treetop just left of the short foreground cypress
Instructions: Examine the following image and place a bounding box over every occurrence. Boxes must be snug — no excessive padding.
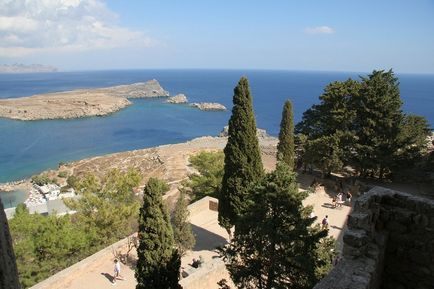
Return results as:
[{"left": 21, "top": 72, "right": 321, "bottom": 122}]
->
[{"left": 65, "top": 169, "right": 141, "bottom": 244}]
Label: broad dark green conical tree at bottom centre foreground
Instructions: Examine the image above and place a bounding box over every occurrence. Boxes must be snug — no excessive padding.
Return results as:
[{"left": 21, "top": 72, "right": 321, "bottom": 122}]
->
[{"left": 222, "top": 162, "right": 327, "bottom": 288}]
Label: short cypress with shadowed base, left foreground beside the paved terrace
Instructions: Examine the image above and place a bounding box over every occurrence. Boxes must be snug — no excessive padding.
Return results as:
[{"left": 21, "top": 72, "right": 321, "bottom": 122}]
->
[{"left": 135, "top": 178, "right": 182, "bottom": 289}]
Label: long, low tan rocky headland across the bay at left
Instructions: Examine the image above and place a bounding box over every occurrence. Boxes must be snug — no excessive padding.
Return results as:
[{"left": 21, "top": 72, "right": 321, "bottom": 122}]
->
[{"left": 0, "top": 79, "right": 169, "bottom": 120}]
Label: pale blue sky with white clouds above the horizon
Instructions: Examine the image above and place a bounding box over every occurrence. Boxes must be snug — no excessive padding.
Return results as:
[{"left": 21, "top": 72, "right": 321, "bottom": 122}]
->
[{"left": 0, "top": 0, "right": 434, "bottom": 73}]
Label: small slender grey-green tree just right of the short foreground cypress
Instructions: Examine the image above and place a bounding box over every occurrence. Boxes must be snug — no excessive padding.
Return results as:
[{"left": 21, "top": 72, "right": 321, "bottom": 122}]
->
[{"left": 172, "top": 193, "right": 196, "bottom": 256}]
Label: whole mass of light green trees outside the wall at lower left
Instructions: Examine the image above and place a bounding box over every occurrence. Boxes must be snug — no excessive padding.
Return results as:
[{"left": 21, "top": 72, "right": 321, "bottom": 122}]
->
[{"left": 10, "top": 170, "right": 140, "bottom": 288}]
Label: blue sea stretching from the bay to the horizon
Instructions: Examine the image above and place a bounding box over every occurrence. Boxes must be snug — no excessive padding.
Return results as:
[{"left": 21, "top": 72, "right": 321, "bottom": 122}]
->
[{"left": 0, "top": 69, "right": 434, "bottom": 207}]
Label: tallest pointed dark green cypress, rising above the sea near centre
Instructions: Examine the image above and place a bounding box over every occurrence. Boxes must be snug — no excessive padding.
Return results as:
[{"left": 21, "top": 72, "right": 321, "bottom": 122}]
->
[{"left": 219, "top": 77, "right": 264, "bottom": 231}]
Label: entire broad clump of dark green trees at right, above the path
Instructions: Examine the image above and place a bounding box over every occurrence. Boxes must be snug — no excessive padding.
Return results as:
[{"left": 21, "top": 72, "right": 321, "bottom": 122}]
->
[{"left": 296, "top": 70, "right": 429, "bottom": 178}]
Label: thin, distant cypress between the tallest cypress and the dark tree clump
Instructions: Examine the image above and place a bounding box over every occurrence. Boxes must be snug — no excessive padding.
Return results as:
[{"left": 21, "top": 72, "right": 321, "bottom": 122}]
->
[{"left": 277, "top": 100, "right": 295, "bottom": 170}]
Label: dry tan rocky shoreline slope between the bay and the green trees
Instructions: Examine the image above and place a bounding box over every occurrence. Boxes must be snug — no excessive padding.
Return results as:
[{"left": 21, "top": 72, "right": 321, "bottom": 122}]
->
[{"left": 0, "top": 134, "right": 278, "bottom": 207}]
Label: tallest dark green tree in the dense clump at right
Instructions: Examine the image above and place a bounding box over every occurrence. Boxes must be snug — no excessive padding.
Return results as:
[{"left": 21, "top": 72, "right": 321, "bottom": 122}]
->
[{"left": 354, "top": 70, "right": 403, "bottom": 178}]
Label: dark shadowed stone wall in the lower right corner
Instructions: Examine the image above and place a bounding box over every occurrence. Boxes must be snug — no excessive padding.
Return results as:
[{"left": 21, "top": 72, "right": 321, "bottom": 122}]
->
[{"left": 314, "top": 187, "right": 434, "bottom": 289}]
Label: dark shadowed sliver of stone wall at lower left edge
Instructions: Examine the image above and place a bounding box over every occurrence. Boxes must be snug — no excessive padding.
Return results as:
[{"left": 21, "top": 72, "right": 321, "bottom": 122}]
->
[{"left": 0, "top": 199, "right": 20, "bottom": 289}]
